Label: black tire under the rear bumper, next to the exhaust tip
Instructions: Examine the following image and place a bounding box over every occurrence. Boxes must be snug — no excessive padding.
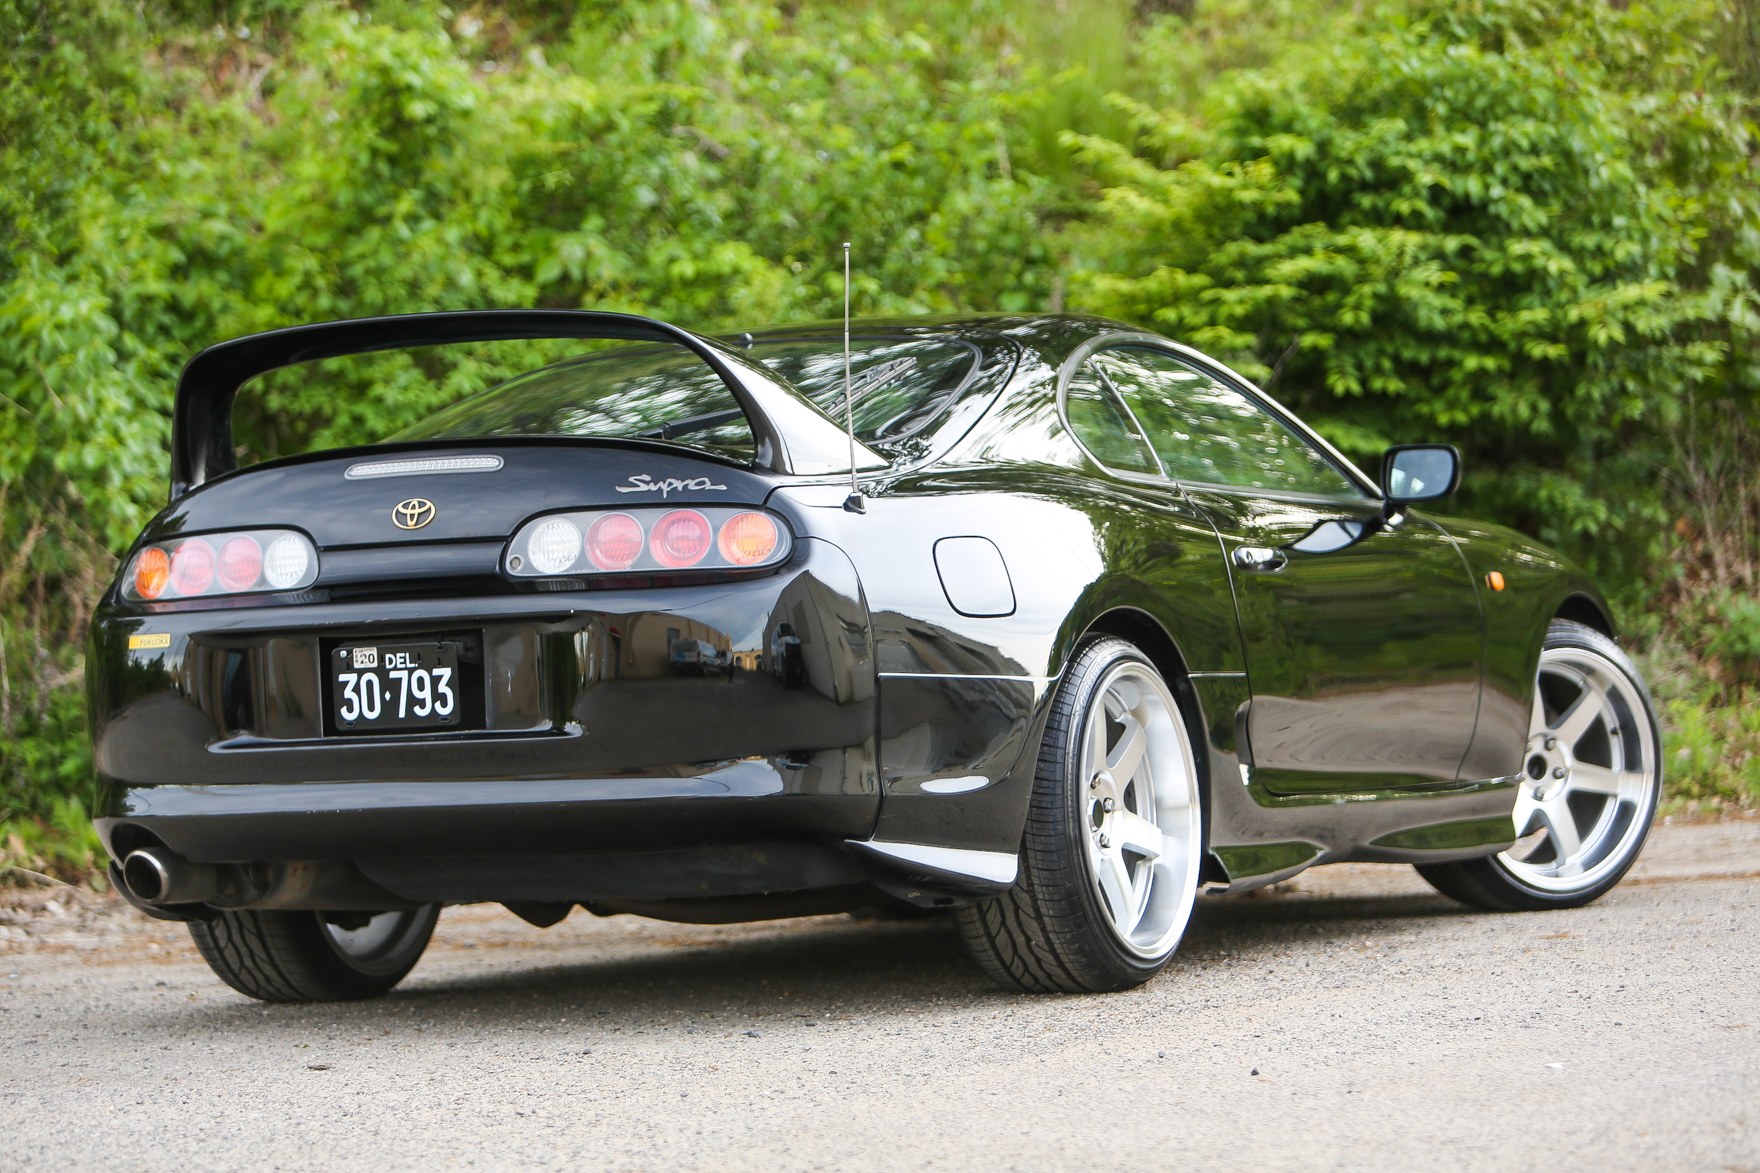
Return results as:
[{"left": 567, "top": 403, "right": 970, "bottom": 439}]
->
[{"left": 190, "top": 904, "right": 440, "bottom": 1002}]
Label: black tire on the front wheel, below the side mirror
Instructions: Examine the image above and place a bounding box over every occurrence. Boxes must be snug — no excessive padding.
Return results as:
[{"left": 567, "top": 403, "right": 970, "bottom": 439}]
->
[{"left": 1417, "top": 620, "right": 1663, "bottom": 912}]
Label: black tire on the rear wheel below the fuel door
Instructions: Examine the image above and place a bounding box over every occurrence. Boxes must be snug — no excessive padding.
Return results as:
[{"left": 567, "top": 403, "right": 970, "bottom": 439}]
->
[{"left": 956, "top": 638, "right": 1202, "bottom": 993}]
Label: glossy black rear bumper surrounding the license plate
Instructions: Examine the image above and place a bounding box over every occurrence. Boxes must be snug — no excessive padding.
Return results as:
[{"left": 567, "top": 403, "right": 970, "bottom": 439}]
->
[{"left": 88, "top": 541, "right": 880, "bottom": 863}]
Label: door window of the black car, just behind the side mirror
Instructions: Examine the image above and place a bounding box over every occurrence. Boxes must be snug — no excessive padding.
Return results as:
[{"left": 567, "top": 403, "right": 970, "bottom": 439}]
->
[{"left": 1070, "top": 347, "right": 1362, "bottom": 497}]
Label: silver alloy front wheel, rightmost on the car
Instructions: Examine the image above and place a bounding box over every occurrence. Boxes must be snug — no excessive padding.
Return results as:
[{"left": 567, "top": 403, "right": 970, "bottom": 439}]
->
[{"left": 1498, "top": 646, "right": 1658, "bottom": 893}]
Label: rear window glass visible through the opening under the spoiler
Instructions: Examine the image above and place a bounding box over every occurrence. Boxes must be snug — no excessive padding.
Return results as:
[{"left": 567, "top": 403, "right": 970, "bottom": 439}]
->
[{"left": 385, "top": 345, "right": 753, "bottom": 463}]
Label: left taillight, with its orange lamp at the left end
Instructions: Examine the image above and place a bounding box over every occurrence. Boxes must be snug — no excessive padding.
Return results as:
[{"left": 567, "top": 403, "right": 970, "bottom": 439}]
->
[{"left": 121, "top": 530, "right": 319, "bottom": 602}]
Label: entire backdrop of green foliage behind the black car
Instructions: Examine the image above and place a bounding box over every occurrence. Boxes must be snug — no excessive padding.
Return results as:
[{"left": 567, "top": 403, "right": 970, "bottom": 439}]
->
[{"left": 0, "top": 0, "right": 1760, "bottom": 858}]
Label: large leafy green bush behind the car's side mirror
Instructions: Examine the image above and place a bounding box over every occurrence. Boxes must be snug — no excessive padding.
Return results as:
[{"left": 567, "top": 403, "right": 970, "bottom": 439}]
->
[{"left": 1070, "top": 0, "right": 1760, "bottom": 594}]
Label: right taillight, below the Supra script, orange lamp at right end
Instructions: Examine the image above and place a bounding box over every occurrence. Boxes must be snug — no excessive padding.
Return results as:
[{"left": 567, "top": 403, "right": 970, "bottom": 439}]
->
[{"left": 502, "top": 505, "right": 794, "bottom": 578}]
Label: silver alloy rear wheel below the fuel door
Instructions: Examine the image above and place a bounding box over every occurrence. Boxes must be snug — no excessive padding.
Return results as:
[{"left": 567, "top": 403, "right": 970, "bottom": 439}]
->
[{"left": 1079, "top": 662, "right": 1204, "bottom": 958}]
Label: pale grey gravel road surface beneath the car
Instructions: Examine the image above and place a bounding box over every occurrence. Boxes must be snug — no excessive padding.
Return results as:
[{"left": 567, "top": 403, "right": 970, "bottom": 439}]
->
[{"left": 0, "top": 819, "right": 1760, "bottom": 1173}]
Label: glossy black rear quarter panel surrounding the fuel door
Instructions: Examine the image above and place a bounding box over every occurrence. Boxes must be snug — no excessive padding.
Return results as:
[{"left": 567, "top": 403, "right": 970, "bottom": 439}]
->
[{"left": 778, "top": 467, "right": 1243, "bottom": 852}]
